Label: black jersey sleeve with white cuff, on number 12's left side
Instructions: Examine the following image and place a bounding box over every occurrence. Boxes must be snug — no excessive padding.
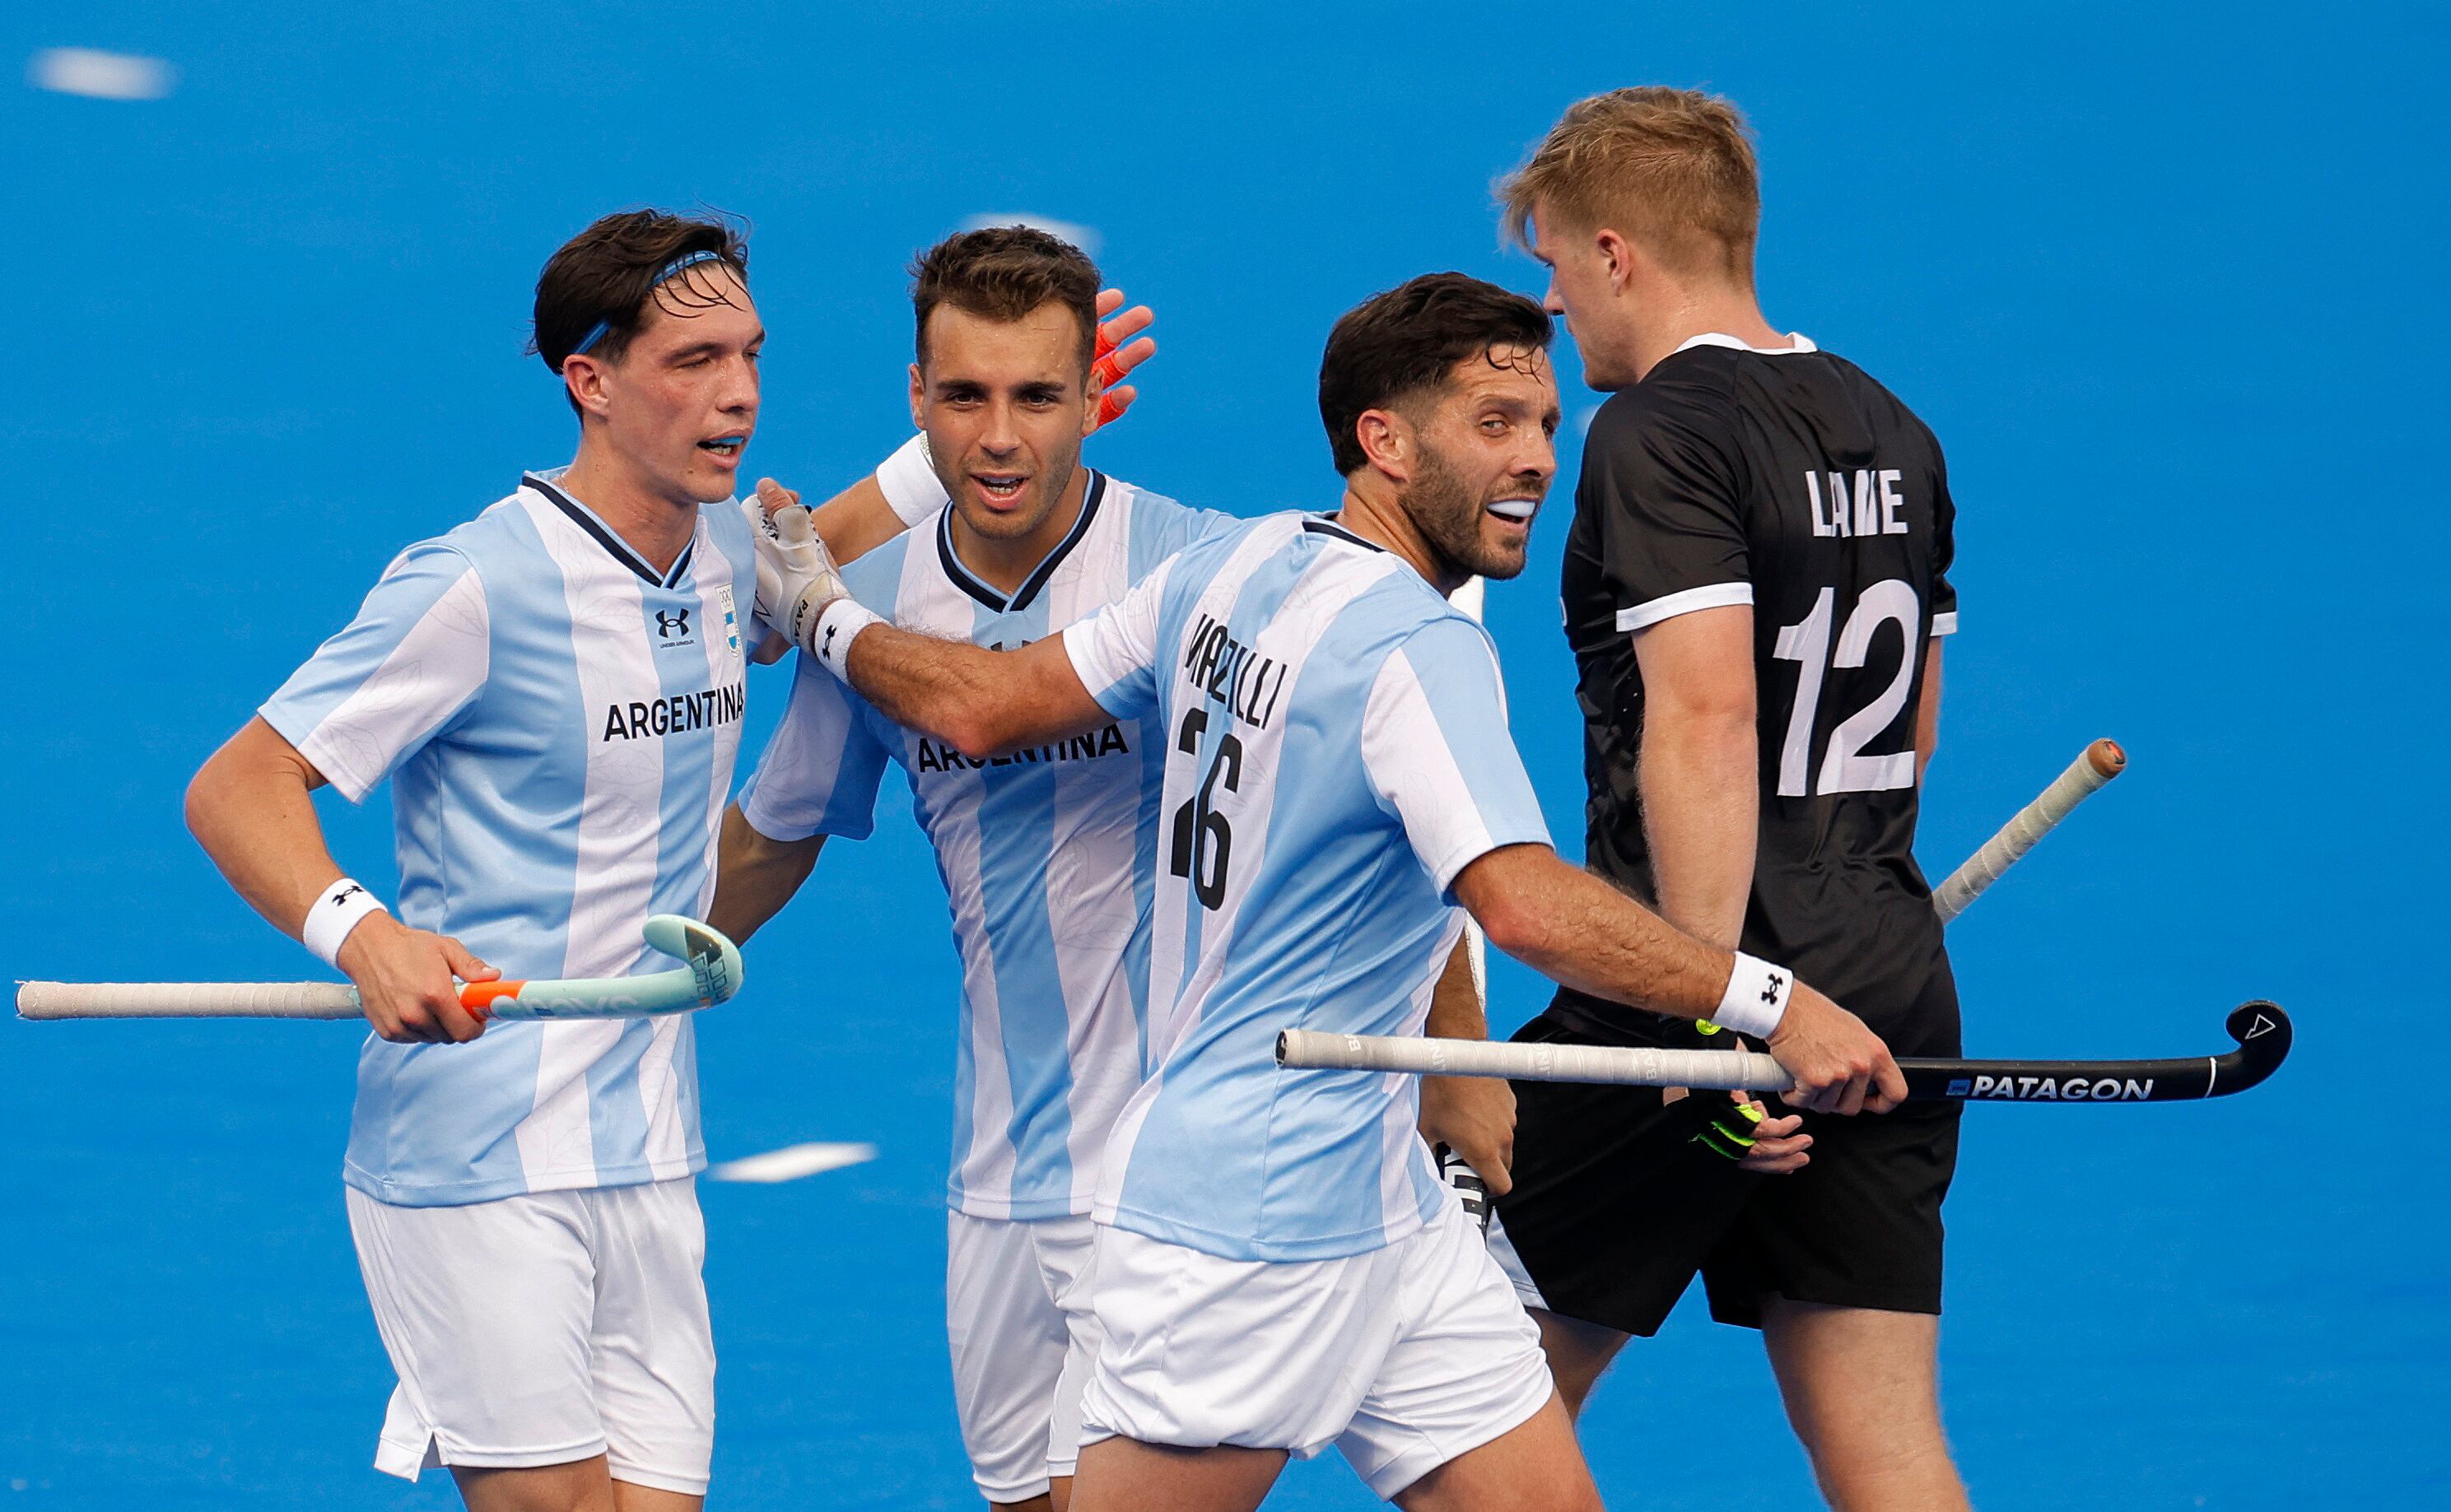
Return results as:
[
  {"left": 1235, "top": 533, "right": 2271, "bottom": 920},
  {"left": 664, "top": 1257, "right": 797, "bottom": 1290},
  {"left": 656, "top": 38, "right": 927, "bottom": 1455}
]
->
[{"left": 1578, "top": 399, "right": 1753, "bottom": 632}]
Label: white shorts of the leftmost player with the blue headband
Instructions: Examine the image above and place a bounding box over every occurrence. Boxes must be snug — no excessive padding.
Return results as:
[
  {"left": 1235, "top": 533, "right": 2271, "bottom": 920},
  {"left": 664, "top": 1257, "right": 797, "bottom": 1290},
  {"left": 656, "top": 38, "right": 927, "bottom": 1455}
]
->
[{"left": 348, "top": 1176, "right": 715, "bottom": 1495}]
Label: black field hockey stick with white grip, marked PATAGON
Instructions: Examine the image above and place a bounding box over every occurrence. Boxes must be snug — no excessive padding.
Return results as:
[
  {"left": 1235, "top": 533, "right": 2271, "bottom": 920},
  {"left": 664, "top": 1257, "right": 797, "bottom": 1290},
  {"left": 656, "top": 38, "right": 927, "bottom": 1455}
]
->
[{"left": 1277, "top": 1003, "right": 2290, "bottom": 1103}]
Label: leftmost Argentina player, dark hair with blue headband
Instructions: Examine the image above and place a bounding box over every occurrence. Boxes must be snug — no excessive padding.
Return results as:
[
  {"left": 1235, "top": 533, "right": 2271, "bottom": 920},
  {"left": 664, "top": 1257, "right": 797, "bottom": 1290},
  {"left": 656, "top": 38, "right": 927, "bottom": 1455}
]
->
[{"left": 189, "top": 211, "right": 765, "bottom": 1512}]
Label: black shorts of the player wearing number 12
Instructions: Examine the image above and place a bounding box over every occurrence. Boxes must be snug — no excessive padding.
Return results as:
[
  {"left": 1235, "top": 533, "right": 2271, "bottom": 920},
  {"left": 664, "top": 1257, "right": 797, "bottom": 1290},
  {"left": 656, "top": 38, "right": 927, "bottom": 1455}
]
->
[{"left": 1498, "top": 965, "right": 1959, "bottom": 1336}]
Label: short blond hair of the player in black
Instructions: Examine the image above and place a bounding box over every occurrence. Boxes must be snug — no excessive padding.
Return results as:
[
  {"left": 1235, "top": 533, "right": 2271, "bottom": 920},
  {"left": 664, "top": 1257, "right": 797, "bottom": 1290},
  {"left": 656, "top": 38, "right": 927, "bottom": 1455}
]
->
[{"left": 1498, "top": 86, "right": 1762, "bottom": 289}]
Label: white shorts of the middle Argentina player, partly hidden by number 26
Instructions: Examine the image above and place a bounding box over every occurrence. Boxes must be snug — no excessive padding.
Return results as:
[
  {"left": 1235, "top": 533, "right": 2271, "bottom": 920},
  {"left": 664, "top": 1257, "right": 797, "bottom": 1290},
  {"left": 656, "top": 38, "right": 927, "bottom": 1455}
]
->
[{"left": 944, "top": 1213, "right": 1098, "bottom": 1502}]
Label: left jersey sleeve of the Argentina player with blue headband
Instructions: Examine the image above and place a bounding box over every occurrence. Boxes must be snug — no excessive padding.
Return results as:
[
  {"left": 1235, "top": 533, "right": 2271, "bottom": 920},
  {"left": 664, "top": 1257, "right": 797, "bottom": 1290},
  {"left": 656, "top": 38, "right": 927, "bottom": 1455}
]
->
[{"left": 258, "top": 542, "right": 492, "bottom": 804}]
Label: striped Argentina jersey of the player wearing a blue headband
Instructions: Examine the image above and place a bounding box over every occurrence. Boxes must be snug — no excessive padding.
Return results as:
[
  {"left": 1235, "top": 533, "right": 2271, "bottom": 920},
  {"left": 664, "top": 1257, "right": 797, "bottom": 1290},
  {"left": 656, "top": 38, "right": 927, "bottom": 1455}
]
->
[{"left": 260, "top": 471, "right": 757, "bottom": 1208}]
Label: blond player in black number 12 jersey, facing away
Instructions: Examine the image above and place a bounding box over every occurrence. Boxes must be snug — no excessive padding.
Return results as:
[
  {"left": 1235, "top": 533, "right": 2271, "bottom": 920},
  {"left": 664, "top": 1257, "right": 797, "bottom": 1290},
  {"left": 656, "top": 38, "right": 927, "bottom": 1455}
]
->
[{"left": 1493, "top": 88, "right": 1966, "bottom": 1512}]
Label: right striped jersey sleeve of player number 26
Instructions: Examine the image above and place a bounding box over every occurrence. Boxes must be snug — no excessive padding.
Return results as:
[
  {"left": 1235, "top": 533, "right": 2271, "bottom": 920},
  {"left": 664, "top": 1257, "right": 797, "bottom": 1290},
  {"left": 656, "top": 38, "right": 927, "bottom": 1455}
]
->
[{"left": 1363, "top": 617, "right": 1549, "bottom": 895}]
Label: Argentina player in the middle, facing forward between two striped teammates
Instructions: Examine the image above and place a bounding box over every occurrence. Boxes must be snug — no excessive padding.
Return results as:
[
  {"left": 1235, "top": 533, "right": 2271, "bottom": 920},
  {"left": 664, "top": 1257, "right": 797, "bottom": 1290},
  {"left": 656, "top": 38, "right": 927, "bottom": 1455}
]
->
[{"left": 711, "top": 226, "right": 1237, "bottom": 1507}]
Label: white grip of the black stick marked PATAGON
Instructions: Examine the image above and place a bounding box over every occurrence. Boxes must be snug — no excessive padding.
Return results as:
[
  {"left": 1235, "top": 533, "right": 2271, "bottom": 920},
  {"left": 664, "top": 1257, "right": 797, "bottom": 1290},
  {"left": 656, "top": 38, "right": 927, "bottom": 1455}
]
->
[{"left": 1277, "top": 1029, "right": 1792, "bottom": 1093}]
